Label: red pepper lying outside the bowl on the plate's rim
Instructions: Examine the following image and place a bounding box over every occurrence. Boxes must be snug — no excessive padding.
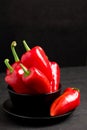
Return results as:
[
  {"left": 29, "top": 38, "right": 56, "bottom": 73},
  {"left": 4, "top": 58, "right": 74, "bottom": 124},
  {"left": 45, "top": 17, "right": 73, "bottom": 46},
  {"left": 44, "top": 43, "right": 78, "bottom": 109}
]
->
[{"left": 50, "top": 88, "right": 80, "bottom": 116}]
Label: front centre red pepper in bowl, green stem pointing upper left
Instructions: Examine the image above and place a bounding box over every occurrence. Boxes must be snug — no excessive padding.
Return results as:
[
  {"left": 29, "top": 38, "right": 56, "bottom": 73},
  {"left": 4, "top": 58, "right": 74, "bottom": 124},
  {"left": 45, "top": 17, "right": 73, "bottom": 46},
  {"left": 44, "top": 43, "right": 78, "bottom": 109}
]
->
[{"left": 20, "top": 64, "right": 50, "bottom": 94}]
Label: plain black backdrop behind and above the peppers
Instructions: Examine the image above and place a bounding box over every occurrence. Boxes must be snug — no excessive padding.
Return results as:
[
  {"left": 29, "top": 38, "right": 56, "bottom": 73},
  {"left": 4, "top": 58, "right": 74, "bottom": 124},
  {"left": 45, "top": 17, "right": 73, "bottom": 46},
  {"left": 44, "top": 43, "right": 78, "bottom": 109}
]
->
[{"left": 0, "top": 0, "right": 87, "bottom": 71}]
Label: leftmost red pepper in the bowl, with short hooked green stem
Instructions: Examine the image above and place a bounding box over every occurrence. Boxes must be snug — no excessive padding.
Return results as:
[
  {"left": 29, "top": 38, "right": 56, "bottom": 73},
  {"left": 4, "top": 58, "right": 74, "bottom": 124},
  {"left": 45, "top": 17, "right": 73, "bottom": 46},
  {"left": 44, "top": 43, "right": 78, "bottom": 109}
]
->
[{"left": 4, "top": 59, "right": 29, "bottom": 93}]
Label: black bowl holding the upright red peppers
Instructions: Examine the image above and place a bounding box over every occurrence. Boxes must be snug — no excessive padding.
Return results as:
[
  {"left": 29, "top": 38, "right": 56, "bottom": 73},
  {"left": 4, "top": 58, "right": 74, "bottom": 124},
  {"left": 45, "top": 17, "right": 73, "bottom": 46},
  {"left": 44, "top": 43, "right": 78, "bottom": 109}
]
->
[{"left": 8, "top": 85, "right": 61, "bottom": 116}]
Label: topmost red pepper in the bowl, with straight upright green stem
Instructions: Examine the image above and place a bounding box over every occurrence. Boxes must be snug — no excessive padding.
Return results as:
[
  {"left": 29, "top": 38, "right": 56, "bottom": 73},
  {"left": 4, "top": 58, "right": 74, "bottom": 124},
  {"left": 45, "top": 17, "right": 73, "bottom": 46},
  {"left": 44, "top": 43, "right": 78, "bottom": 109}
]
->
[{"left": 21, "top": 41, "right": 52, "bottom": 83}]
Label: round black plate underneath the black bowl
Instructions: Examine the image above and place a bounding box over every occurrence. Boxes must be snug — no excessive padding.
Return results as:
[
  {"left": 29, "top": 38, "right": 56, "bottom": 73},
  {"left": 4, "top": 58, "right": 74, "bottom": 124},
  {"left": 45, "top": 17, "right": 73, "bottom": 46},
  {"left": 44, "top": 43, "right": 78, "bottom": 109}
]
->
[{"left": 2, "top": 99, "right": 74, "bottom": 125}]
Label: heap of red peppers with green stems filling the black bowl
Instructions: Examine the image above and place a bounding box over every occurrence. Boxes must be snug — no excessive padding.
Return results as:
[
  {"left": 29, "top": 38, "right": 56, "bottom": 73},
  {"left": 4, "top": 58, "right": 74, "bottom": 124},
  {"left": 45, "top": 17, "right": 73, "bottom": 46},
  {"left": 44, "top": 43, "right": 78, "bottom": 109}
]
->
[{"left": 4, "top": 40, "right": 60, "bottom": 94}]
